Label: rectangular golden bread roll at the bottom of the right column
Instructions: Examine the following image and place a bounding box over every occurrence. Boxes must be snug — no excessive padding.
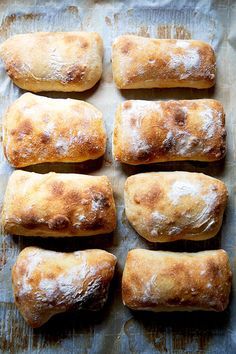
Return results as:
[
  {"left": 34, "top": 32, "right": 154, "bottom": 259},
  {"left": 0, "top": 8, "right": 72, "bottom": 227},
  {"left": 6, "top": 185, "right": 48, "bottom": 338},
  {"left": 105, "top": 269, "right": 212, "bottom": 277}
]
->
[{"left": 122, "top": 249, "right": 232, "bottom": 312}]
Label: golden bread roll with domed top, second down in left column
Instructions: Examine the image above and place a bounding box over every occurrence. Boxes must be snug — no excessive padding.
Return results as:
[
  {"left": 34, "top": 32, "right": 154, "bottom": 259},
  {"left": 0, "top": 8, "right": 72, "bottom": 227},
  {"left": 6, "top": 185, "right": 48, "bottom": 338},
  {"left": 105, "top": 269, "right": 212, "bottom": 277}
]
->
[{"left": 3, "top": 93, "right": 106, "bottom": 167}]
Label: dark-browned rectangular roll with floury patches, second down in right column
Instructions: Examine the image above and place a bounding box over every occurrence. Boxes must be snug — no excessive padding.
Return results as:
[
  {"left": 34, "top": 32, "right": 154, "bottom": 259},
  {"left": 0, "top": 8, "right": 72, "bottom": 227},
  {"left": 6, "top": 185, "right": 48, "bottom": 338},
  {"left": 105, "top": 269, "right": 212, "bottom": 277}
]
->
[{"left": 113, "top": 99, "right": 226, "bottom": 165}]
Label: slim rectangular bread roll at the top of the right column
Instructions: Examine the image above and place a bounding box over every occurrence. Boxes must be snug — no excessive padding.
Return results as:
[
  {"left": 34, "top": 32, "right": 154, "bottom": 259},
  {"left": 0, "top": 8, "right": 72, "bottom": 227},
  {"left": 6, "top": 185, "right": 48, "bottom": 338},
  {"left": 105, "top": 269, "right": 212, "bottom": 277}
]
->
[{"left": 112, "top": 35, "right": 216, "bottom": 89}]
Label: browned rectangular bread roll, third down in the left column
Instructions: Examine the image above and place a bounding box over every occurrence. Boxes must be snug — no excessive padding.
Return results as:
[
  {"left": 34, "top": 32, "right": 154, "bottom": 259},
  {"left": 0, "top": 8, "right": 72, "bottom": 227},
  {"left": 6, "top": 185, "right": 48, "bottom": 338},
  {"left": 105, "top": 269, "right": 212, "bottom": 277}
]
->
[{"left": 2, "top": 170, "right": 116, "bottom": 237}]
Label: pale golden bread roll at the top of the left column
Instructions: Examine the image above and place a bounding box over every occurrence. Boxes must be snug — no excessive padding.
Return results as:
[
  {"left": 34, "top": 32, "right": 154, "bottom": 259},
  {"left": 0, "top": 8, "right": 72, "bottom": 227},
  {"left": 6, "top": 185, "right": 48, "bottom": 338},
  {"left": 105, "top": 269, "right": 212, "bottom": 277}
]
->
[{"left": 0, "top": 32, "right": 103, "bottom": 92}]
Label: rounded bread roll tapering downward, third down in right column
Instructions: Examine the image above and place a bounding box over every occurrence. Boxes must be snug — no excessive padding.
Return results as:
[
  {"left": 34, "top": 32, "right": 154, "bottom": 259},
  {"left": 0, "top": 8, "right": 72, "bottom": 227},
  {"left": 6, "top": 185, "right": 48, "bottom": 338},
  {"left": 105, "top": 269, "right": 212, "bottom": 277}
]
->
[{"left": 124, "top": 172, "right": 228, "bottom": 242}]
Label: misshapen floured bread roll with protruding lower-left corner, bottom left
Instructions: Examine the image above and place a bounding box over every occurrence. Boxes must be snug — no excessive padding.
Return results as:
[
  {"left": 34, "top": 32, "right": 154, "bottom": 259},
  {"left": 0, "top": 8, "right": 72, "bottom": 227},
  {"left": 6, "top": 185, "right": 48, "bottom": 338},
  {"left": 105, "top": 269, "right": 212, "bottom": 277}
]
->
[{"left": 12, "top": 247, "right": 116, "bottom": 328}]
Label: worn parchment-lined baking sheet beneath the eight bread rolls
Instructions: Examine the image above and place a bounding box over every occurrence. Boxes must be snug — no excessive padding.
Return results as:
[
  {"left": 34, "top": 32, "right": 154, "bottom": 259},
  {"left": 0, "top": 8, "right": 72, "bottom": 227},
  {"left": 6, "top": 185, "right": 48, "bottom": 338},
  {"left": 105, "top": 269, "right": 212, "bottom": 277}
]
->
[{"left": 0, "top": 0, "right": 236, "bottom": 353}]
